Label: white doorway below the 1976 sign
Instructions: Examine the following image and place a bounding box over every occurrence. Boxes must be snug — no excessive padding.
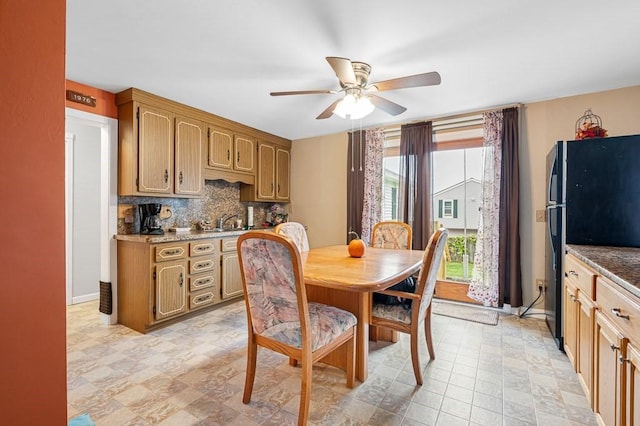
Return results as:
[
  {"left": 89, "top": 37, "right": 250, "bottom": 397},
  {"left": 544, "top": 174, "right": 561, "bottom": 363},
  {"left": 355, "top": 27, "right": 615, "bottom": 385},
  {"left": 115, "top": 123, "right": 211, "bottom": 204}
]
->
[{"left": 65, "top": 108, "right": 118, "bottom": 323}]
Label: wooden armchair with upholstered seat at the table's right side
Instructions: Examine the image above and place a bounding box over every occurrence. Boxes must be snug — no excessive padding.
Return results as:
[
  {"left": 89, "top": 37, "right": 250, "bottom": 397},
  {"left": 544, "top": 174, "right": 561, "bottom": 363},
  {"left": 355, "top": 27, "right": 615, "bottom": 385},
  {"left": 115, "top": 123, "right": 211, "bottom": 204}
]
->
[{"left": 371, "top": 229, "right": 448, "bottom": 385}]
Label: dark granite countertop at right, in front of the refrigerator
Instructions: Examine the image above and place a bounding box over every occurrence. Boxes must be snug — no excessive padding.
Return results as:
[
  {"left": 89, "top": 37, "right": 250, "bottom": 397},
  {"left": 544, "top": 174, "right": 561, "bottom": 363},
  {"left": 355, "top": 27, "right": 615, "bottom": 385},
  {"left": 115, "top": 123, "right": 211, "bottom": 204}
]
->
[{"left": 567, "top": 244, "right": 640, "bottom": 297}]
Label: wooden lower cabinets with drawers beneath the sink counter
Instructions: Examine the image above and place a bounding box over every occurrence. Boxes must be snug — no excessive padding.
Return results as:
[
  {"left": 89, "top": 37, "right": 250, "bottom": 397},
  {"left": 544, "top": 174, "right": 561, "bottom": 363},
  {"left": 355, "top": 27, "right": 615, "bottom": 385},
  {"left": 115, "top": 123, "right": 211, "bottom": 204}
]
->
[{"left": 118, "top": 238, "right": 242, "bottom": 333}]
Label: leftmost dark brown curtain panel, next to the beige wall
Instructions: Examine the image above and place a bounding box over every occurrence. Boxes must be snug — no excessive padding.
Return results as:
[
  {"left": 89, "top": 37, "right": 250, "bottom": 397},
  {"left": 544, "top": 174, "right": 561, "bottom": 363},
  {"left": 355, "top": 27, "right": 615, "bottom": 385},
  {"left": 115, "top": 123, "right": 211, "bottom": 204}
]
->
[{"left": 345, "top": 130, "right": 365, "bottom": 242}]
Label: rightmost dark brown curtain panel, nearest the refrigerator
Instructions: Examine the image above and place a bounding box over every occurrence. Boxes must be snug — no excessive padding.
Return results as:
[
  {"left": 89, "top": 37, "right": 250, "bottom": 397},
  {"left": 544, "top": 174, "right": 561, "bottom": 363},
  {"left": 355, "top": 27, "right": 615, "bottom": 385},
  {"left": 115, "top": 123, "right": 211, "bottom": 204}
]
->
[{"left": 499, "top": 108, "right": 522, "bottom": 307}]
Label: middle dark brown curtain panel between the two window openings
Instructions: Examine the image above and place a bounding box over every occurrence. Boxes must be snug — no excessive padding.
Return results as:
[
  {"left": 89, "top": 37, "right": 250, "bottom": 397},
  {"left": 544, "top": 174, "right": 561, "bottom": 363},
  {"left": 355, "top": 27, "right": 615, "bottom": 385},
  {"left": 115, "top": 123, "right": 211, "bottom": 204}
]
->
[{"left": 399, "top": 121, "right": 433, "bottom": 250}]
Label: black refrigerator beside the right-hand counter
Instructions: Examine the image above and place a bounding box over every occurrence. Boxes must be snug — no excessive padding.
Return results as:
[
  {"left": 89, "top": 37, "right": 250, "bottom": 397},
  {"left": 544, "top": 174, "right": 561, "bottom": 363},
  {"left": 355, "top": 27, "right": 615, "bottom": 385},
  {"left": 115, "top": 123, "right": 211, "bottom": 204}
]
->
[{"left": 544, "top": 135, "right": 640, "bottom": 350}]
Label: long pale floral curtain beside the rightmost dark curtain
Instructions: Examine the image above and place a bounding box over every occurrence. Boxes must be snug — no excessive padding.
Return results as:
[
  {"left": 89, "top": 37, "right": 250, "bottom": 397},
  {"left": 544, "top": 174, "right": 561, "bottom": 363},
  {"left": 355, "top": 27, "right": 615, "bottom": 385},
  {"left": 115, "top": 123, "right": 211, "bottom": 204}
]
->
[{"left": 467, "top": 111, "right": 502, "bottom": 307}]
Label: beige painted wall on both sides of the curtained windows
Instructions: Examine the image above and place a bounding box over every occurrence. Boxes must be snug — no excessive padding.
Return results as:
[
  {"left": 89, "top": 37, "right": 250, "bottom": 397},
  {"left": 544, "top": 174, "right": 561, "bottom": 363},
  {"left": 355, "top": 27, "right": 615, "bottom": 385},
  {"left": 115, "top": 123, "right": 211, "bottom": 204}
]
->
[{"left": 291, "top": 86, "right": 640, "bottom": 308}]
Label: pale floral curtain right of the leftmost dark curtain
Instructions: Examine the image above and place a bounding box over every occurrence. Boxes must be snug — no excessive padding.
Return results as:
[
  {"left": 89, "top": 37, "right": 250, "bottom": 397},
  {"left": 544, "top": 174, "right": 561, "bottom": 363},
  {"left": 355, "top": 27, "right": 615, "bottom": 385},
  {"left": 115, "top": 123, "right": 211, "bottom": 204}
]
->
[{"left": 360, "top": 129, "right": 384, "bottom": 243}]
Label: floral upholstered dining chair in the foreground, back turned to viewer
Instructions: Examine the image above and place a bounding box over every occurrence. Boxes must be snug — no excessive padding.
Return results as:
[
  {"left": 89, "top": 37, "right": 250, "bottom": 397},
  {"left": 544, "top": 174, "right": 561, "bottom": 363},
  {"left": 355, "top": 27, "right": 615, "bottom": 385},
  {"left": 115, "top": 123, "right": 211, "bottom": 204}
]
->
[{"left": 238, "top": 231, "right": 357, "bottom": 425}]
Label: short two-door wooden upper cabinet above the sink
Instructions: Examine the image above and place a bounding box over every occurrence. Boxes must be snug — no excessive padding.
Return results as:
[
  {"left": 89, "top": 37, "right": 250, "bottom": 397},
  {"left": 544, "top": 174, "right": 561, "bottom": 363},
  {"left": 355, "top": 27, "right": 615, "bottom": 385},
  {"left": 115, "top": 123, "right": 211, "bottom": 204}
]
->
[{"left": 206, "top": 126, "right": 255, "bottom": 174}]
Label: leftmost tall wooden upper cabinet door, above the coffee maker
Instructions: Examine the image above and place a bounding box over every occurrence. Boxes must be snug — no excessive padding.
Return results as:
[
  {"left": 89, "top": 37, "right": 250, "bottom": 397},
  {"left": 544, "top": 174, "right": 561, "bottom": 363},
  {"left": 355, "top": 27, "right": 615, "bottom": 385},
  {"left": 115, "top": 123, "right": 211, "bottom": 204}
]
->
[{"left": 138, "top": 105, "right": 174, "bottom": 194}]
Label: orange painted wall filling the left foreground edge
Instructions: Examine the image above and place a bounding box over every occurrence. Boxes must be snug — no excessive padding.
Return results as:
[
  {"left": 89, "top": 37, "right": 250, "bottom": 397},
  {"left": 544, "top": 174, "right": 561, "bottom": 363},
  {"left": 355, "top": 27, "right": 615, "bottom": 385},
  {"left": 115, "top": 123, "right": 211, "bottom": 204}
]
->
[{"left": 0, "top": 0, "right": 67, "bottom": 425}]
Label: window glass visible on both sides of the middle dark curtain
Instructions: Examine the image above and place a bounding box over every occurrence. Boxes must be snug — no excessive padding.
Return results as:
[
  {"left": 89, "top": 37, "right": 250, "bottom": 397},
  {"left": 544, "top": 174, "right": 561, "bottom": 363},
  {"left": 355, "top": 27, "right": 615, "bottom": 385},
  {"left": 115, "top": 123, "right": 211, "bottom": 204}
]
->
[{"left": 383, "top": 115, "right": 484, "bottom": 301}]
